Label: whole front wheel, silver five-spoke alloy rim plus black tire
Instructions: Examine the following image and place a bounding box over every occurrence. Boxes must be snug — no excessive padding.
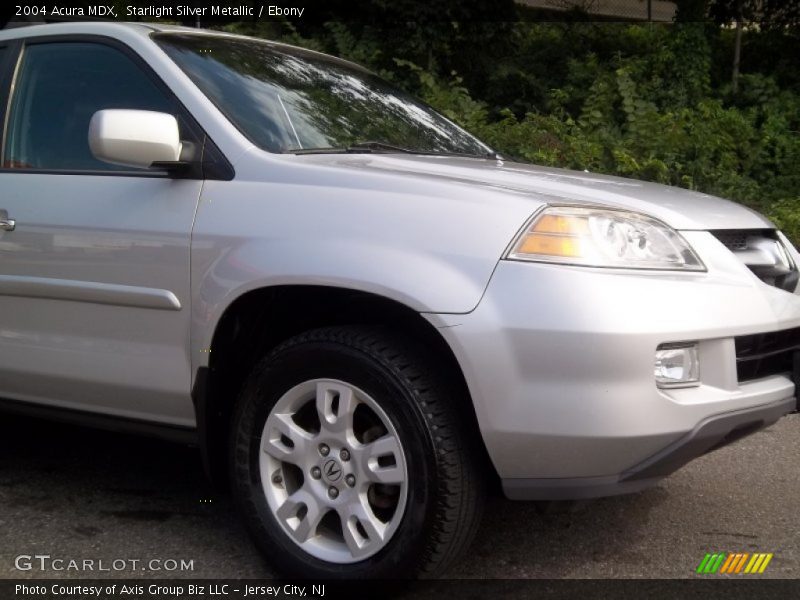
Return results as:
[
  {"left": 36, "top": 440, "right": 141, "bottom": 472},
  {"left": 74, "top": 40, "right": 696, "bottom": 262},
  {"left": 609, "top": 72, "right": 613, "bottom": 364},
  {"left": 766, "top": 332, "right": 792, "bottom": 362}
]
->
[{"left": 231, "top": 327, "right": 483, "bottom": 578}]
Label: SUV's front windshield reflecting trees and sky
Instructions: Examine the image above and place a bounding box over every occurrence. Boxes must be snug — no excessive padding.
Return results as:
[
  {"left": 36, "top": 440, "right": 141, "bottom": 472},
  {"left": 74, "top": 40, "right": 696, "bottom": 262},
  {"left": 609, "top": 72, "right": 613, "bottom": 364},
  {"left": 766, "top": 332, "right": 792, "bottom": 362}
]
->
[{"left": 154, "top": 33, "right": 491, "bottom": 156}]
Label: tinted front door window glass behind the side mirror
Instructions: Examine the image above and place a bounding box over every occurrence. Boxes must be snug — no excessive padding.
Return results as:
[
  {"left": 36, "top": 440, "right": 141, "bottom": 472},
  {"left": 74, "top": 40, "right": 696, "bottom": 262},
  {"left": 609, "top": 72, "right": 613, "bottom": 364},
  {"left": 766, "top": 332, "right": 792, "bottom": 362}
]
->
[{"left": 0, "top": 42, "right": 177, "bottom": 171}]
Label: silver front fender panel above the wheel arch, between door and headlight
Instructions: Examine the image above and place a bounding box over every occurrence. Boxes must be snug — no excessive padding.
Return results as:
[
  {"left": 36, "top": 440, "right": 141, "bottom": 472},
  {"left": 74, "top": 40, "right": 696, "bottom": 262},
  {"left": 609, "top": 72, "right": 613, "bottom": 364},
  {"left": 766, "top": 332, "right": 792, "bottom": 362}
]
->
[{"left": 192, "top": 176, "right": 529, "bottom": 371}]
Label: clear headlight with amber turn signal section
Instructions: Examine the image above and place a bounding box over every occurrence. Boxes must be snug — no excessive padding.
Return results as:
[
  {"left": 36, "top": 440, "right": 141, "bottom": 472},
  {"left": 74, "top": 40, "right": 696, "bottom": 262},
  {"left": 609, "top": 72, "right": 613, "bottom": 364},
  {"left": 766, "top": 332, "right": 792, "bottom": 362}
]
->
[{"left": 508, "top": 206, "right": 706, "bottom": 271}]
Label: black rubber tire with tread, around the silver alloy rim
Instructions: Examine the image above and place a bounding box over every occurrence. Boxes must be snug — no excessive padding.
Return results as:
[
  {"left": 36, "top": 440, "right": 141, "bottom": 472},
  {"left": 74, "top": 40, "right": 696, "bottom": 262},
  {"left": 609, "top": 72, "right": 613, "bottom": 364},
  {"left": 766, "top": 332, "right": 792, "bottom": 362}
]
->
[{"left": 230, "top": 326, "right": 484, "bottom": 579}]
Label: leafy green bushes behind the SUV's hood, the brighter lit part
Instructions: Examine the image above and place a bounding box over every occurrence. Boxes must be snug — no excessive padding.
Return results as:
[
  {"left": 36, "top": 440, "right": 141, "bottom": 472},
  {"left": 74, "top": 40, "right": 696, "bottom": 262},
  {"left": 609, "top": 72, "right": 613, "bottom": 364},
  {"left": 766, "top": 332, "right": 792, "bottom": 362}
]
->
[{"left": 406, "top": 24, "right": 800, "bottom": 243}]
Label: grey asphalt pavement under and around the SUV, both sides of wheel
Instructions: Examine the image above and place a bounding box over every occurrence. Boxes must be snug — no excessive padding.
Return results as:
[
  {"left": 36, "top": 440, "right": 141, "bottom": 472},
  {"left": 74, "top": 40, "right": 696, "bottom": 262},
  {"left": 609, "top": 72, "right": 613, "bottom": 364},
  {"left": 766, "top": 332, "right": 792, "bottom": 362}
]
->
[{"left": 0, "top": 414, "right": 800, "bottom": 578}]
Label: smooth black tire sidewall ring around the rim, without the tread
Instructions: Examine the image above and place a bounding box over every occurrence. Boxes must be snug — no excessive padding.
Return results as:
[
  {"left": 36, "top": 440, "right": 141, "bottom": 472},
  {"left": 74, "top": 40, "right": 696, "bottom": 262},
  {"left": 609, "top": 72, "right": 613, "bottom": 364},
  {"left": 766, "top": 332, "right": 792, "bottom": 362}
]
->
[{"left": 231, "top": 341, "right": 437, "bottom": 579}]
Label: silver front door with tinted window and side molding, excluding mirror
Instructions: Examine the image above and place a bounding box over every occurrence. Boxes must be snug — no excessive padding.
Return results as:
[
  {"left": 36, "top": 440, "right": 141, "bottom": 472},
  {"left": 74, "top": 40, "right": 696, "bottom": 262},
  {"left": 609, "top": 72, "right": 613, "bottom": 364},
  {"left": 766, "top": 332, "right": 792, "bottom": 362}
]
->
[{"left": 0, "top": 37, "right": 202, "bottom": 426}]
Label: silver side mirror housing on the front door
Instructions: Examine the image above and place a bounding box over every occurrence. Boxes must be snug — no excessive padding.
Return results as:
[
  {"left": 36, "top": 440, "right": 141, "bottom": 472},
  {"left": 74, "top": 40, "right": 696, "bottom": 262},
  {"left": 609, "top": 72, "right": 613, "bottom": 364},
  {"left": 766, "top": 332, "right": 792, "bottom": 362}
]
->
[{"left": 89, "top": 108, "right": 182, "bottom": 168}]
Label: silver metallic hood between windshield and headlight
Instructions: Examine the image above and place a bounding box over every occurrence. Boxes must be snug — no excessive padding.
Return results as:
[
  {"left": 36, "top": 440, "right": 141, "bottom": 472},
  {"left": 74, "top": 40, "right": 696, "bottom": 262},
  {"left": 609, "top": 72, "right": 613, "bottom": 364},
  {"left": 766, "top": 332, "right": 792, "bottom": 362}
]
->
[{"left": 302, "top": 154, "right": 774, "bottom": 230}]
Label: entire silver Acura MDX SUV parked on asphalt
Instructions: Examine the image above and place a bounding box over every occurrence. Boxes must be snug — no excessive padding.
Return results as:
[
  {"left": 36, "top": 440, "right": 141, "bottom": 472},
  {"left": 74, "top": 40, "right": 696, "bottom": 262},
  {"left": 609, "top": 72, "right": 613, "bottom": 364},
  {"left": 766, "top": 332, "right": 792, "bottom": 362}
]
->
[{"left": 0, "top": 23, "right": 800, "bottom": 578}]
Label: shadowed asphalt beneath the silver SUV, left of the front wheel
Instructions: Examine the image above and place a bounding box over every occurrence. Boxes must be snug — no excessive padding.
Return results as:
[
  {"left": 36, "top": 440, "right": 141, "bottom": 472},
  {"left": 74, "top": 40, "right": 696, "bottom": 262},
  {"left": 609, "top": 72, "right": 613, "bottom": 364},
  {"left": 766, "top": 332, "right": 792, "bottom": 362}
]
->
[{"left": 0, "top": 414, "right": 272, "bottom": 578}]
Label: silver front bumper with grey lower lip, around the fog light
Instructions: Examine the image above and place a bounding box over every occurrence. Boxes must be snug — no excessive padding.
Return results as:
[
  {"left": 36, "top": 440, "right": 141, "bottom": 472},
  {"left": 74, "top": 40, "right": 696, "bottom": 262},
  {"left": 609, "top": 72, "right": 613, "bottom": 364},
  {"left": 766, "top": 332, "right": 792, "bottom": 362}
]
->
[{"left": 427, "top": 232, "right": 800, "bottom": 499}]
